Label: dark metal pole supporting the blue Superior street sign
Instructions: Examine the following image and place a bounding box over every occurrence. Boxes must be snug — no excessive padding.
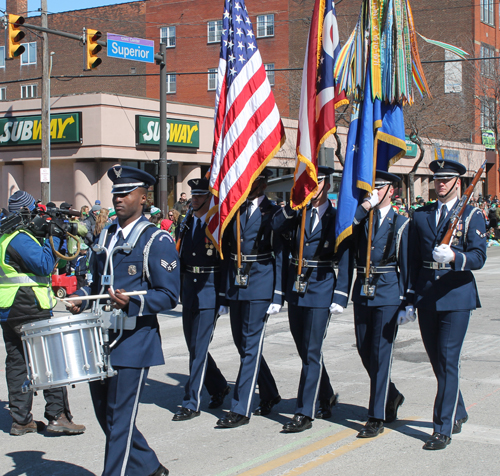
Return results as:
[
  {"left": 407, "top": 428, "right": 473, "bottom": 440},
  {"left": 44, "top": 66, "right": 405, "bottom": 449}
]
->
[{"left": 158, "top": 43, "right": 168, "bottom": 213}]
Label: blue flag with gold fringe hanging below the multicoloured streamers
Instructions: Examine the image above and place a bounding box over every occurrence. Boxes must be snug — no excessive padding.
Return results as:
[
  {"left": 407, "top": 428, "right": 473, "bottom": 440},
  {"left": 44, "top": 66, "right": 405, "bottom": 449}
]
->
[{"left": 335, "top": 69, "right": 406, "bottom": 251}]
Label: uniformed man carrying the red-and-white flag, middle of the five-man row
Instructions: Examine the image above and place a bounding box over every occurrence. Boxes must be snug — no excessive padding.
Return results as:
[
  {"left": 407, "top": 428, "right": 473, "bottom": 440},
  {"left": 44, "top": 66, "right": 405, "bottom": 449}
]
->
[{"left": 273, "top": 166, "right": 349, "bottom": 433}]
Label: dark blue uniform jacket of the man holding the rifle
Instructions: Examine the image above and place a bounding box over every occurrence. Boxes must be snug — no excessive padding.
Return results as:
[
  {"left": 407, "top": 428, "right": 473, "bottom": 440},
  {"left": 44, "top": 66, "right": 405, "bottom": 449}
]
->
[{"left": 408, "top": 203, "right": 486, "bottom": 311}]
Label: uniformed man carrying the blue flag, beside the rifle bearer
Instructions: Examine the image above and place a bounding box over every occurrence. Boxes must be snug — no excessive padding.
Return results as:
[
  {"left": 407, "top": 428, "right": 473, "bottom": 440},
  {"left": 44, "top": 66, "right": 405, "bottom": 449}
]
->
[{"left": 352, "top": 170, "right": 409, "bottom": 438}]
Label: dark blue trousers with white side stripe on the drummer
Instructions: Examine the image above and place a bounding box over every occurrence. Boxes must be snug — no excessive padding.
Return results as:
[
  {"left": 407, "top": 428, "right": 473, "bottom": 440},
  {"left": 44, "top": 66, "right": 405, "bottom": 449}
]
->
[{"left": 90, "top": 367, "right": 160, "bottom": 476}]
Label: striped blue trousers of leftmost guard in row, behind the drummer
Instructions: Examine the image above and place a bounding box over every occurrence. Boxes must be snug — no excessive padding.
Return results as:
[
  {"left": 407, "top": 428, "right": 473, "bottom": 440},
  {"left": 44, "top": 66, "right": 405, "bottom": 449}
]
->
[{"left": 182, "top": 303, "right": 227, "bottom": 412}]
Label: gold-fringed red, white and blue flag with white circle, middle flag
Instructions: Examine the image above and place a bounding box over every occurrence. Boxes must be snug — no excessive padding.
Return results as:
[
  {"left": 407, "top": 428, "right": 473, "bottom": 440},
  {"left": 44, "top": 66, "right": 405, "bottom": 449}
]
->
[{"left": 291, "top": 0, "right": 348, "bottom": 209}]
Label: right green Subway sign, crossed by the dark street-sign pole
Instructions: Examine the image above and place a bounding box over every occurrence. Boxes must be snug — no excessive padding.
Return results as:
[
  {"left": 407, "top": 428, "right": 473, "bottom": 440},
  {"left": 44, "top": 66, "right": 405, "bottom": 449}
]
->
[{"left": 135, "top": 116, "right": 200, "bottom": 149}]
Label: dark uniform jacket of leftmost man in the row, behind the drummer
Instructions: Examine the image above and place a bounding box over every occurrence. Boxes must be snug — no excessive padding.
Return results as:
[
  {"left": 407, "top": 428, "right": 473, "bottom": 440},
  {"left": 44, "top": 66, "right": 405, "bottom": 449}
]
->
[{"left": 180, "top": 219, "right": 225, "bottom": 309}]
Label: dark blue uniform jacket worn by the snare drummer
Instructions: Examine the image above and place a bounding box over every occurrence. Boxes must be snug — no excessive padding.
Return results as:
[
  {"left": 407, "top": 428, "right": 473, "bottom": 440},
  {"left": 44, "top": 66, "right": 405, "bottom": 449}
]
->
[{"left": 75, "top": 217, "right": 180, "bottom": 368}]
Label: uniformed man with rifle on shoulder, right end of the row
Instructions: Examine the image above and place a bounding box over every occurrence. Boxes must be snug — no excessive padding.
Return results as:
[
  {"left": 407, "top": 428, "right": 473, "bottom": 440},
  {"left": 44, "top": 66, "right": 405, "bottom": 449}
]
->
[{"left": 407, "top": 160, "right": 486, "bottom": 450}]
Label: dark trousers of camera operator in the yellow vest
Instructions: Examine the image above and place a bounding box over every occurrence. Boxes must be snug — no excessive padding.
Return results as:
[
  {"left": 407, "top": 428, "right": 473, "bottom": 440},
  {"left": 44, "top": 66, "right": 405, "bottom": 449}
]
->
[{"left": 2, "top": 322, "right": 73, "bottom": 425}]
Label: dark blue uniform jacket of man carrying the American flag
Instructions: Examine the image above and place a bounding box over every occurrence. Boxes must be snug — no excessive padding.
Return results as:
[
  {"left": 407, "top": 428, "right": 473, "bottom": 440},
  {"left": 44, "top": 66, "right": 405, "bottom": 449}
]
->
[{"left": 224, "top": 197, "right": 284, "bottom": 306}]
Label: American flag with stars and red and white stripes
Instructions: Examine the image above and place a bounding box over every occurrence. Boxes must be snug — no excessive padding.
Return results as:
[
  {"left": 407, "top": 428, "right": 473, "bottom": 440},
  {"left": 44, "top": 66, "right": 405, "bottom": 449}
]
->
[{"left": 207, "top": 0, "right": 285, "bottom": 255}]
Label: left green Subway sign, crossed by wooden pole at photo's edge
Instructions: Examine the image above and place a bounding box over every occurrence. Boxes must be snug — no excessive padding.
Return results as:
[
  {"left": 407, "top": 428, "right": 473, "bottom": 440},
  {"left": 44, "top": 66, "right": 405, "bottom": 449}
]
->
[{"left": 0, "top": 112, "right": 82, "bottom": 147}]
